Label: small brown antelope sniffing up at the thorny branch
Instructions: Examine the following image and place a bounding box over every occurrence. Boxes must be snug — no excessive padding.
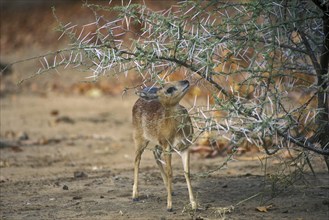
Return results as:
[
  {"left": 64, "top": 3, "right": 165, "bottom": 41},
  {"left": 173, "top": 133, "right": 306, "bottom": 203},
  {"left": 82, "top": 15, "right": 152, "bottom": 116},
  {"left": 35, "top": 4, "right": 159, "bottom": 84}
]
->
[{"left": 132, "top": 80, "right": 197, "bottom": 211}]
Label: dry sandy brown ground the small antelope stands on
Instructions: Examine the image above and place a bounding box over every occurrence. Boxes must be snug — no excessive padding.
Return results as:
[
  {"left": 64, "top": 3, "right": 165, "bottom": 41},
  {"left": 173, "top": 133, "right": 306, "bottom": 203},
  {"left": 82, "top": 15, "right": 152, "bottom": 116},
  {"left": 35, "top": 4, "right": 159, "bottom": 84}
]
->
[{"left": 0, "top": 94, "right": 329, "bottom": 219}]
